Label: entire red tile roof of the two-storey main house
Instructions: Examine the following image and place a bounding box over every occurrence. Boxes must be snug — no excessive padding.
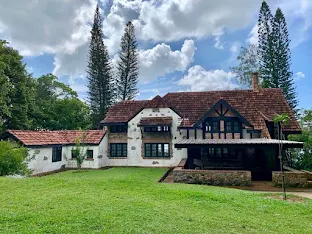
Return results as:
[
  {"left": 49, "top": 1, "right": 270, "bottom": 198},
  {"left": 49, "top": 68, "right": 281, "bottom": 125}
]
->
[{"left": 102, "top": 89, "right": 301, "bottom": 132}]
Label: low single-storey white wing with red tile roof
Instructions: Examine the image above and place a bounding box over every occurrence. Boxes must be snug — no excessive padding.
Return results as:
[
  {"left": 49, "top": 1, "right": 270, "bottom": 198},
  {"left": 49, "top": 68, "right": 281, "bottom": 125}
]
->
[{"left": 1, "top": 130, "right": 107, "bottom": 174}]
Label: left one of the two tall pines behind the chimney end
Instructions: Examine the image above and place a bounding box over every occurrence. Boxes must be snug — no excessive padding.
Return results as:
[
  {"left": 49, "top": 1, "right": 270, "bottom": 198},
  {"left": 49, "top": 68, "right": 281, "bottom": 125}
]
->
[{"left": 258, "top": 1, "right": 276, "bottom": 88}]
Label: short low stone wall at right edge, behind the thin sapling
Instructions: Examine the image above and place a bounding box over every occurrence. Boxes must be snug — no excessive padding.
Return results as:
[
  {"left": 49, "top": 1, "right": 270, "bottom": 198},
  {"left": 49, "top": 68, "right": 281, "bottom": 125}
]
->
[{"left": 272, "top": 171, "right": 311, "bottom": 188}]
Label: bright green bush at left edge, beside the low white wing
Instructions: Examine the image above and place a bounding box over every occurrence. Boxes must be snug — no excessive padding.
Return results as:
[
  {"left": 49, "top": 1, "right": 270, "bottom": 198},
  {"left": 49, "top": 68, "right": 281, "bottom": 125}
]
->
[{"left": 0, "top": 141, "right": 30, "bottom": 176}]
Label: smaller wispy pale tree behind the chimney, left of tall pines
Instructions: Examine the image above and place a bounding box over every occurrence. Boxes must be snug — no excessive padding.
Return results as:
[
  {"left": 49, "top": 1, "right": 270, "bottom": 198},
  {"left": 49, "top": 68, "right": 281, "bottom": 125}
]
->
[{"left": 231, "top": 44, "right": 260, "bottom": 89}]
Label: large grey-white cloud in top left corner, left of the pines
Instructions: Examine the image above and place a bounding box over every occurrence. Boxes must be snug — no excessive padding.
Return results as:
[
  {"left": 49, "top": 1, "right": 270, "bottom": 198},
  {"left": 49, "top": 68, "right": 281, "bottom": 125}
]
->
[{"left": 0, "top": 0, "right": 96, "bottom": 56}]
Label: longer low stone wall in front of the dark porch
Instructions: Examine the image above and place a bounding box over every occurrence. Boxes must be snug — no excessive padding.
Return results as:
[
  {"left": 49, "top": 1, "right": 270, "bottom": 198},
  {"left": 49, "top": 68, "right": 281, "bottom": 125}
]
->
[{"left": 173, "top": 167, "right": 251, "bottom": 186}]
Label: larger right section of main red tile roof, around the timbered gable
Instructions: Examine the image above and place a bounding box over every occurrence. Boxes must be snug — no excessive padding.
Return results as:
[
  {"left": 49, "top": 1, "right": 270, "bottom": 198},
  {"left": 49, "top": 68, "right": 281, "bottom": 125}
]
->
[{"left": 163, "top": 89, "right": 301, "bottom": 131}]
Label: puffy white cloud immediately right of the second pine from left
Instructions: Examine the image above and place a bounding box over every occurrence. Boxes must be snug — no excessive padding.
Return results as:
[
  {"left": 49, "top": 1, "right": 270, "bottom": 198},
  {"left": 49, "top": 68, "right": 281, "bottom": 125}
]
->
[{"left": 139, "top": 40, "right": 196, "bottom": 82}]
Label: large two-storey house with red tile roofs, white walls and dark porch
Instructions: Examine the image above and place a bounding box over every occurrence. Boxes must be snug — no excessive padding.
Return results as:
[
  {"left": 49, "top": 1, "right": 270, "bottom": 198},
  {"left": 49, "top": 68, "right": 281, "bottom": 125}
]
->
[{"left": 0, "top": 74, "right": 303, "bottom": 184}]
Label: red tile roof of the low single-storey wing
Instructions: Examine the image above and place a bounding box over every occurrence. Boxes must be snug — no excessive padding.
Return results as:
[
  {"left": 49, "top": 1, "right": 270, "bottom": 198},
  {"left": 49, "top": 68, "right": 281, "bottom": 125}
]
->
[{"left": 7, "top": 130, "right": 105, "bottom": 146}]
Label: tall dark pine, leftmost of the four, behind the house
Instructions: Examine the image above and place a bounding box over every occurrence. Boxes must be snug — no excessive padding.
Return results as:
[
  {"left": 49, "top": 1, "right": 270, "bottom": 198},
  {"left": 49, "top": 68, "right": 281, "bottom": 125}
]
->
[{"left": 87, "top": 5, "right": 113, "bottom": 128}]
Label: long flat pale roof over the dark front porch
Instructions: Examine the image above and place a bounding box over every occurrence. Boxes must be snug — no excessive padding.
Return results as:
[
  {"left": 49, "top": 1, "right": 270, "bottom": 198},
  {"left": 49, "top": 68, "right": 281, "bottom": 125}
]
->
[{"left": 175, "top": 138, "right": 303, "bottom": 148}]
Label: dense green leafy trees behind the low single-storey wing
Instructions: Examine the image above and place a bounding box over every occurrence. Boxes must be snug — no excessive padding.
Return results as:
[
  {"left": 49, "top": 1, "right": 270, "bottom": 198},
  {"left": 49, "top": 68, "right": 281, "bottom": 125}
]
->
[{"left": 0, "top": 41, "right": 90, "bottom": 133}]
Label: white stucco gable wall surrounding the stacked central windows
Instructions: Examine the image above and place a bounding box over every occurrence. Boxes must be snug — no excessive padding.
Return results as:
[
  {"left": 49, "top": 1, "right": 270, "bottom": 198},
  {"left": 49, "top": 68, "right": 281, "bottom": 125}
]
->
[{"left": 105, "top": 108, "right": 187, "bottom": 167}]
